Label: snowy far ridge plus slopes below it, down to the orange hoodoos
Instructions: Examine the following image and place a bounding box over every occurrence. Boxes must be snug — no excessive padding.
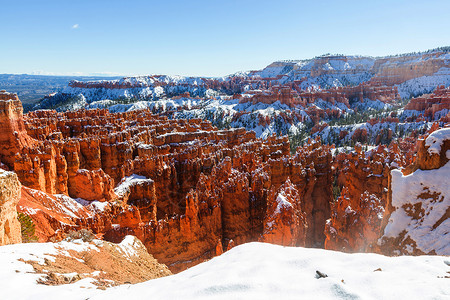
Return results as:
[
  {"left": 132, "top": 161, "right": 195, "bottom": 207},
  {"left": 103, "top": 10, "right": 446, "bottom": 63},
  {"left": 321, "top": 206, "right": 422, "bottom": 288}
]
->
[{"left": 36, "top": 48, "right": 450, "bottom": 143}]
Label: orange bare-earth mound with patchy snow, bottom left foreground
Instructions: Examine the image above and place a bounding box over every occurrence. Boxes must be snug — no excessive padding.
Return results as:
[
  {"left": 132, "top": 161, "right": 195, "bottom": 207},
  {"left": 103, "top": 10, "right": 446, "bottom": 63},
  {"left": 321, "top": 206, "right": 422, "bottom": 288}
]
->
[{"left": 0, "top": 235, "right": 171, "bottom": 300}]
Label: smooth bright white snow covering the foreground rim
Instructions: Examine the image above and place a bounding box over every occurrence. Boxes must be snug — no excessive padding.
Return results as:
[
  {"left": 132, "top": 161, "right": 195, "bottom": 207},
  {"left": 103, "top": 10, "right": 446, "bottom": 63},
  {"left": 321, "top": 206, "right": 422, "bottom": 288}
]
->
[{"left": 0, "top": 243, "right": 450, "bottom": 300}]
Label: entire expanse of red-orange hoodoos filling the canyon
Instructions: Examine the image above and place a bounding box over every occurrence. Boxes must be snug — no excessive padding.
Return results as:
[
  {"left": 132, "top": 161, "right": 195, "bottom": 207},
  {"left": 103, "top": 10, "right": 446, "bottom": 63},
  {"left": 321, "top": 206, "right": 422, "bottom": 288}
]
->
[{"left": 0, "top": 74, "right": 449, "bottom": 272}]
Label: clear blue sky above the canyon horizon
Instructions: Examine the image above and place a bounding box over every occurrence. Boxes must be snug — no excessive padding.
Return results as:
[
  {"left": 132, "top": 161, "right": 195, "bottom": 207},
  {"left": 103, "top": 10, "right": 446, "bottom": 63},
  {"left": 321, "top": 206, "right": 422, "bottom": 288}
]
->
[{"left": 0, "top": 0, "right": 450, "bottom": 76}]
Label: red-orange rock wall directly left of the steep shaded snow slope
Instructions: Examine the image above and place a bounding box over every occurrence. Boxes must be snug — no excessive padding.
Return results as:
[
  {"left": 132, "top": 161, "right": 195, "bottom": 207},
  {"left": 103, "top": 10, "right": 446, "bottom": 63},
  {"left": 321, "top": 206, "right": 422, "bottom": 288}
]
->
[{"left": 325, "top": 144, "right": 405, "bottom": 252}]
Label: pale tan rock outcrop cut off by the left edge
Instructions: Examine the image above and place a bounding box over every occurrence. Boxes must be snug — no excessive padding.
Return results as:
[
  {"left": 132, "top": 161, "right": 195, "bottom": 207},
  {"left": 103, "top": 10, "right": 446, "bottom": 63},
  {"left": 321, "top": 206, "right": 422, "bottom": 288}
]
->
[{"left": 0, "top": 169, "right": 22, "bottom": 246}]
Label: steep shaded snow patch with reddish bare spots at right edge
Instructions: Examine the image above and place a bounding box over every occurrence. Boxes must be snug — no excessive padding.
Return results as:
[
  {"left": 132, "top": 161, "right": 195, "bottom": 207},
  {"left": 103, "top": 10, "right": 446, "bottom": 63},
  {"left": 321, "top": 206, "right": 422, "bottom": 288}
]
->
[{"left": 384, "top": 162, "right": 450, "bottom": 255}]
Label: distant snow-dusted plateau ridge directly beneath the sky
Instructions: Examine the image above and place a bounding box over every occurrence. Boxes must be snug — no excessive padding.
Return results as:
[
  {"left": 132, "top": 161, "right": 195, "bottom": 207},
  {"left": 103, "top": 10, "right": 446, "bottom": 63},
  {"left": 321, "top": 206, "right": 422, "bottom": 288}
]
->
[{"left": 36, "top": 47, "right": 450, "bottom": 109}]
